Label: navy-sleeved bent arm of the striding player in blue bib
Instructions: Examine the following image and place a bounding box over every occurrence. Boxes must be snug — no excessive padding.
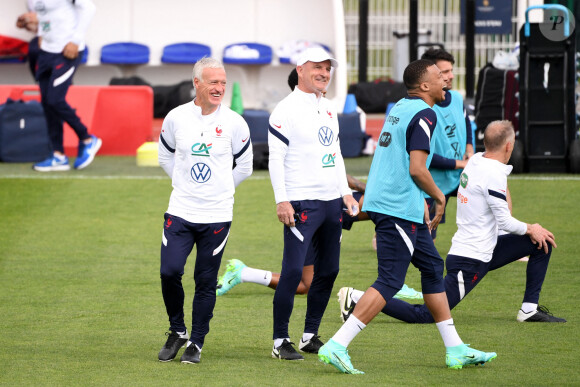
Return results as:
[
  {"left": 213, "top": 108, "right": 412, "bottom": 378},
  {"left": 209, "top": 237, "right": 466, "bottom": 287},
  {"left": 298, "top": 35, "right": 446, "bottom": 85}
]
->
[{"left": 406, "top": 109, "right": 445, "bottom": 229}]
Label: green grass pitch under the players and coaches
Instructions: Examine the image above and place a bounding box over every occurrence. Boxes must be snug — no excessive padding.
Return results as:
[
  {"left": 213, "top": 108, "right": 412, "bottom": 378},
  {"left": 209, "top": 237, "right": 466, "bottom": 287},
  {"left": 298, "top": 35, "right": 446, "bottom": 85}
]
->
[{"left": 0, "top": 157, "right": 580, "bottom": 386}]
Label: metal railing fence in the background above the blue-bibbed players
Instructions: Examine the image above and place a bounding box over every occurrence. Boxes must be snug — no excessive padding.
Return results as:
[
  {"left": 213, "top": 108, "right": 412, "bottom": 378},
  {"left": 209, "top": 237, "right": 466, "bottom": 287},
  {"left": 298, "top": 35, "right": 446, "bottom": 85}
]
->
[{"left": 343, "top": 0, "right": 517, "bottom": 92}]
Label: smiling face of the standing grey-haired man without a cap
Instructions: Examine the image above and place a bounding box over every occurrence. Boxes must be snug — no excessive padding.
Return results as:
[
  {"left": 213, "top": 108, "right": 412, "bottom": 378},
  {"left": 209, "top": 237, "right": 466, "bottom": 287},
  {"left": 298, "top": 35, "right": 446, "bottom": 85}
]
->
[{"left": 193, "top": 67, "right": 226, "bottom": 115}]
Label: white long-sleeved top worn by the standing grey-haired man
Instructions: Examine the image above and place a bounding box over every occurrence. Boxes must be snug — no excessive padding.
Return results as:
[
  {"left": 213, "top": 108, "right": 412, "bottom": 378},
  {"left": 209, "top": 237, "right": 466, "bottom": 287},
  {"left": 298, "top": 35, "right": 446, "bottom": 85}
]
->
[{"left": 159, "top": 101, "right": 253, "bottom": 223}]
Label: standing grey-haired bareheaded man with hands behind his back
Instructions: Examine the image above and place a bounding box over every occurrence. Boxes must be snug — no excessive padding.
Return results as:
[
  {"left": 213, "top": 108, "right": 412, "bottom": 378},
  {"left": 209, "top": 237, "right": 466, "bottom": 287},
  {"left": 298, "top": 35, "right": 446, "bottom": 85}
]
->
[{"left": 158, "top": 58, "right": 253, "bottom": 363}]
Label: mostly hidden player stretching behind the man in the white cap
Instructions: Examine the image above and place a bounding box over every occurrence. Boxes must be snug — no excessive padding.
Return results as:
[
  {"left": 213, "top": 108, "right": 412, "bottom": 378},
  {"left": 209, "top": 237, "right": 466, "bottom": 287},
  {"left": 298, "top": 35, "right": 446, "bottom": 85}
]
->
[{"left": 217, "top": 174, "right": 423, "bottom": 300}]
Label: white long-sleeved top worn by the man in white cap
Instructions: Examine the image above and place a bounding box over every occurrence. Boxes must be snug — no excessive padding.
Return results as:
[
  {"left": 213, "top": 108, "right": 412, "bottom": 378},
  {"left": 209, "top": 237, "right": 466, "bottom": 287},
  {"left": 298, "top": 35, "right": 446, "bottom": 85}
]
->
[{"left": 268, "top": 88, "right": 351, "bottom": 203}]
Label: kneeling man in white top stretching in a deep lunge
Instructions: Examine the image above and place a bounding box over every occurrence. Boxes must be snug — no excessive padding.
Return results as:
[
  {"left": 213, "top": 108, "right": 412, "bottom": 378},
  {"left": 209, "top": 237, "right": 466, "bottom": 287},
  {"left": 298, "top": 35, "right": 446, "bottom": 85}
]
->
[{"left": 340, "top": 121, "right": 566, "bottom": 323}]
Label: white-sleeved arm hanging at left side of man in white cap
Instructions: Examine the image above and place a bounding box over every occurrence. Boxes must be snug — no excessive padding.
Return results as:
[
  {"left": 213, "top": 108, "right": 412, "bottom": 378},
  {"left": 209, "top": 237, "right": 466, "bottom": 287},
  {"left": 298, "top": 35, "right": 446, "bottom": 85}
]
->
[{"left": 268, "top": 110, "right": 295, "bottom": 226}]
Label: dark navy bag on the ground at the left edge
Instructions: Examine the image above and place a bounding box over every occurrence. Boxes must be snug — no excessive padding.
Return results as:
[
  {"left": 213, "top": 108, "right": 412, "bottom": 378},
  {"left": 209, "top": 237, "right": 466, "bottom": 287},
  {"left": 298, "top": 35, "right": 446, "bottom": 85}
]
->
[{"left": 0, "top": 99, "right": 52, "bottom": 163}]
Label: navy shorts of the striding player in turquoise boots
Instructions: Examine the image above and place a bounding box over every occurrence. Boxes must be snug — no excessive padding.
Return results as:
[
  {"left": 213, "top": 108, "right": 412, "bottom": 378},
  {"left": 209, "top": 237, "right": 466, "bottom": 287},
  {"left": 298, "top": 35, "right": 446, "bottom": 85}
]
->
[{"left": 367, "top": 211, "right": 445, "bottom": 301}]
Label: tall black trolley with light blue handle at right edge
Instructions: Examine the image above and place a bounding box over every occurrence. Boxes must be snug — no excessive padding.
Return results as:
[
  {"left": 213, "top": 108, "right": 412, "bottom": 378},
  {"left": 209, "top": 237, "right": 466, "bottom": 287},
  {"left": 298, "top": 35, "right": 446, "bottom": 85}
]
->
[{"left": 512, "top": 4, "right": 580, "bottom": 173}]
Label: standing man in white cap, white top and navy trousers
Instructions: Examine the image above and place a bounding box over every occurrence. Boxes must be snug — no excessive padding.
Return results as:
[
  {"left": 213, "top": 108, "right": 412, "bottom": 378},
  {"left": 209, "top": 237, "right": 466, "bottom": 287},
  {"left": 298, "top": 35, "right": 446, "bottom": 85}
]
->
[{"left": 268, "top": 47, "right": 358, "bottom": 360}]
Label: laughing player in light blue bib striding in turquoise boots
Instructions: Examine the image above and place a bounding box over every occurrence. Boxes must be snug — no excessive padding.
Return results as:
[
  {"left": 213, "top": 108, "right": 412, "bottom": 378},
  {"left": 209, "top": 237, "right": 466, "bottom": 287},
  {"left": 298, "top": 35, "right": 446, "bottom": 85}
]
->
[{"left": 318, "top": 60, "right": 497, "bottom": 374}]
